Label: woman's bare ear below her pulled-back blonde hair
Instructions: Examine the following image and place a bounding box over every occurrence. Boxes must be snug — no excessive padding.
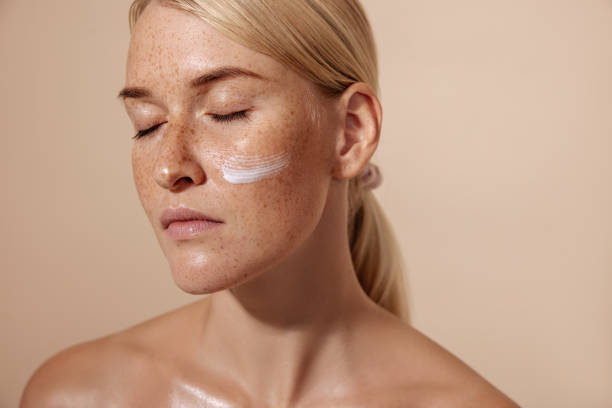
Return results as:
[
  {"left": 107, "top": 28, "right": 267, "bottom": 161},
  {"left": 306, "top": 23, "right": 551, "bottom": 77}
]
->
[{"left": 333, "top": 82, "right": 382, "bottom": 179}]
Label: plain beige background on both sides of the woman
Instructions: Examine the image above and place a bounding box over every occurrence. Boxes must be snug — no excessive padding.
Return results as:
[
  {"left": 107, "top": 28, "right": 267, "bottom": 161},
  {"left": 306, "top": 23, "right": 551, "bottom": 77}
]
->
[{"left": 0, "top": 0, "right": 612, "bottom": 408}]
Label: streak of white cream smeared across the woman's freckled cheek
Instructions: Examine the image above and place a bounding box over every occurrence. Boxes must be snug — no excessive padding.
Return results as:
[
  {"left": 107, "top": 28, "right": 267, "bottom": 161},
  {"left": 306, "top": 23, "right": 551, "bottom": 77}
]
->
[{"left": 210, "top": 153, "right": 289, "bottom": 184}]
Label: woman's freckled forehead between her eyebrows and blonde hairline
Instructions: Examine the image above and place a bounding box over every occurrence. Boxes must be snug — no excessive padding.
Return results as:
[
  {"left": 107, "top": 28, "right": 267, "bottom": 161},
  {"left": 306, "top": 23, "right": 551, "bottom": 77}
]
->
[{"left": 126, "top": 2, "right": 291, "bottom": 86}]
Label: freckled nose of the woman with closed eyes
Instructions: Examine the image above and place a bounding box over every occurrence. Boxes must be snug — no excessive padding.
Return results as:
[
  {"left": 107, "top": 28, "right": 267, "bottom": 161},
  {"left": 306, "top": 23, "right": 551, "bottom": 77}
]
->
[{"left": 153, "top": 123, "right": 206, "bottom": 192}]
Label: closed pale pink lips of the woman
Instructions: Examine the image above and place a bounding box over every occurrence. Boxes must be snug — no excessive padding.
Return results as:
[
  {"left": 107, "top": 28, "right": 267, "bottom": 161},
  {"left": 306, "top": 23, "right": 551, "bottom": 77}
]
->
[{"left": 160, "top": 207, "right": 223, "bottom": 240}]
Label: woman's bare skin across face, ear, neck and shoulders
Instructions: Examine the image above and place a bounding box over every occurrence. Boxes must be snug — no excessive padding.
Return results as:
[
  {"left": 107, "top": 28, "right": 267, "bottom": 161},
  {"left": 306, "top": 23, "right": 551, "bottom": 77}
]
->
[{"left": 21, "top": 3, "right": 517, "bottom": 408}]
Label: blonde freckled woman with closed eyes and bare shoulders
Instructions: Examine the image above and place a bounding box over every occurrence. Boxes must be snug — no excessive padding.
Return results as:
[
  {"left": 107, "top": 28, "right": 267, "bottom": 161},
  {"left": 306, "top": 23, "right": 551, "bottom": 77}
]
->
[{"left": 22, "top": 0, "right": 516, "bottom": 407}]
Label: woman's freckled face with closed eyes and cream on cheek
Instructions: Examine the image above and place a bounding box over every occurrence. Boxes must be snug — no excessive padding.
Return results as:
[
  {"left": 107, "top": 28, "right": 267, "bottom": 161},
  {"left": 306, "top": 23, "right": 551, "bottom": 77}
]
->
[{"left": 123, "top": 2, "right": 334, "bottom": 293}]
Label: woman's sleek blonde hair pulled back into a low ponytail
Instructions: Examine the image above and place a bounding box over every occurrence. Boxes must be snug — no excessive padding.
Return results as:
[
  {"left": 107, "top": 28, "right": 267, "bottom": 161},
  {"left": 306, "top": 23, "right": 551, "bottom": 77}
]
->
[{"left": 129, "top": 0, "right": 410, "bottom": 322}]
